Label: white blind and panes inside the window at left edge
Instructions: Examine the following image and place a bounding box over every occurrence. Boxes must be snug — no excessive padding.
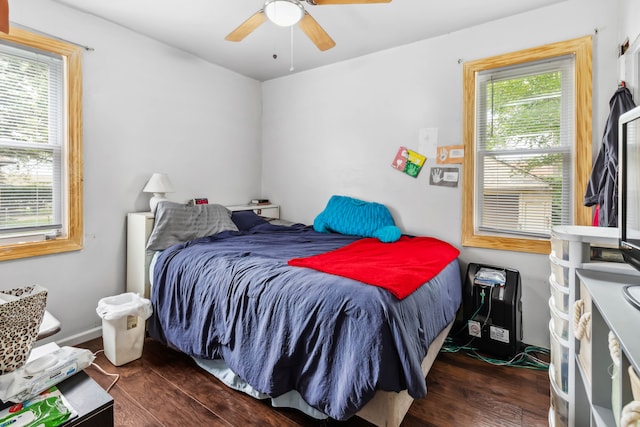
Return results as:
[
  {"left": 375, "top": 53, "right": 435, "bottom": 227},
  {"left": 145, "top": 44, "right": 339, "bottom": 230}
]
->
[{"left": 0, "top": 44, "right": 65, "bottom": 240}]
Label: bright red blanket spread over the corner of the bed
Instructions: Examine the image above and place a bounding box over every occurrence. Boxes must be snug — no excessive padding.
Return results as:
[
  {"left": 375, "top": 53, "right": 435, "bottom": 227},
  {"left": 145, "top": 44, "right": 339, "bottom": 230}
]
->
[{"left": 289, "top": 236, "right": 460, "bottom": 299}]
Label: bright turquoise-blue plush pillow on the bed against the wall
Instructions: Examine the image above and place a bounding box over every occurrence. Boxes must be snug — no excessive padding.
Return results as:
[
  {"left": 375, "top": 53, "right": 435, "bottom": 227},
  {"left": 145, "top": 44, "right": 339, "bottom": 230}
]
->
[{"left": 313, "top": 196, "right": 402, "bottom": 242}]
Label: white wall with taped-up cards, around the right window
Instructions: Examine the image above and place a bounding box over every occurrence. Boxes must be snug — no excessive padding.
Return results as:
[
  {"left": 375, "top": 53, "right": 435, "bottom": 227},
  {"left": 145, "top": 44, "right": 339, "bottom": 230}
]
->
[{"left": 262, "top": 0, "right": 620, "bottom": 347}]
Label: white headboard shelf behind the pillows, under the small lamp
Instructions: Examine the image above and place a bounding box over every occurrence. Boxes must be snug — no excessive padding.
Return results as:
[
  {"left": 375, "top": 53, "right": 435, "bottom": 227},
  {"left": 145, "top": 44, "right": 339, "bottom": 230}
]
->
[{"left": 126, "top": 204, "right": 280, "bottom": 298}]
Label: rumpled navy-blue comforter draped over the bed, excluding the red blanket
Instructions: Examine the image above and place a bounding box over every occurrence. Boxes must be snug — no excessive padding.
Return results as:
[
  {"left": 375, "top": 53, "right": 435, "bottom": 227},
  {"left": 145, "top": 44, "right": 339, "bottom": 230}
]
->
[{"left": 149, "top": 224, "right": 461, "bottom": 420}]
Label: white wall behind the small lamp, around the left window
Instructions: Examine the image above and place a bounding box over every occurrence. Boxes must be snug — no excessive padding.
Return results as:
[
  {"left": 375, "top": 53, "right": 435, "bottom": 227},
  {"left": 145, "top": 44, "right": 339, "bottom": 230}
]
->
[{"left": 0, "top": 0, "right": 261, "bottom": 344}]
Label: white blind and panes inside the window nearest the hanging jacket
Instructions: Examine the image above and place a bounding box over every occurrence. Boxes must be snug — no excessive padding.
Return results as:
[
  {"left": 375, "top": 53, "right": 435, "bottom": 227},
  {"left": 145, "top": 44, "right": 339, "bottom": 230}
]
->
[{"left": 474, "top": 56, "right": 575, "bottom": 238}]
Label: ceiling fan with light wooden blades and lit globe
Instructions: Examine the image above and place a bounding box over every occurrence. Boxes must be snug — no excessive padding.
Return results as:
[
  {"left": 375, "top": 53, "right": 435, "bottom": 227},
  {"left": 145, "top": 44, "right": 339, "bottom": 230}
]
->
[{"left": 225, "top": 0, "right": 391, "bottom": 51}]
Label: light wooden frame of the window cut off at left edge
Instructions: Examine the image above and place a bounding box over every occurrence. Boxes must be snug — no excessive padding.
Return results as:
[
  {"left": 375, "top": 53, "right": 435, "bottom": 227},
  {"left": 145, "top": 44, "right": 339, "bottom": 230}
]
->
[{"left": 0, "top": 27, "right": 84, "bottom": 261}]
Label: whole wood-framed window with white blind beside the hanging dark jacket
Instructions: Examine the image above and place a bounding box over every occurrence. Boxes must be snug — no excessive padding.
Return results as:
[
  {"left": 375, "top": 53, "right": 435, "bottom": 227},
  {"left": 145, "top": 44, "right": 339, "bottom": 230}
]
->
[{"left": 462, "top": 37, "right": 592, "bottom": 253}]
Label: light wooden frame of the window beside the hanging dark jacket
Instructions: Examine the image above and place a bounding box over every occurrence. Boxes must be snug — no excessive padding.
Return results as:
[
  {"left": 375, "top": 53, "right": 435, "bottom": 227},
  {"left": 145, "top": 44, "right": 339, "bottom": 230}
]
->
[{"left": 462, "top": 36, "right": 593, "bottom": 254}]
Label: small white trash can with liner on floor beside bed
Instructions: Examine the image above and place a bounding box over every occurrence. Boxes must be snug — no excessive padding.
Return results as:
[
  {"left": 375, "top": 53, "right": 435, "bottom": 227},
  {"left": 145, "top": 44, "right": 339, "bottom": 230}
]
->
[{"left": 96, "top": 292, "right": 152, "bottom": 366}]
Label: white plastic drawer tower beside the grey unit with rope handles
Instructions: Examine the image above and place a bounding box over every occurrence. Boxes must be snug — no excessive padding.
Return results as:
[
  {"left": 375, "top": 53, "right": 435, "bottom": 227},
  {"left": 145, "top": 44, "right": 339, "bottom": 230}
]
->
[{"left": 549, "top": 226, "right": 638, "bottom": 427}]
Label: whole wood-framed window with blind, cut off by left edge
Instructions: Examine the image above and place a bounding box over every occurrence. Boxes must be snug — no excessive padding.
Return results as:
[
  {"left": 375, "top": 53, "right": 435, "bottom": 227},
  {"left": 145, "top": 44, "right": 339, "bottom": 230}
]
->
[{"left": 0, "top": 28, "right": 83, "bottom": 260}]
